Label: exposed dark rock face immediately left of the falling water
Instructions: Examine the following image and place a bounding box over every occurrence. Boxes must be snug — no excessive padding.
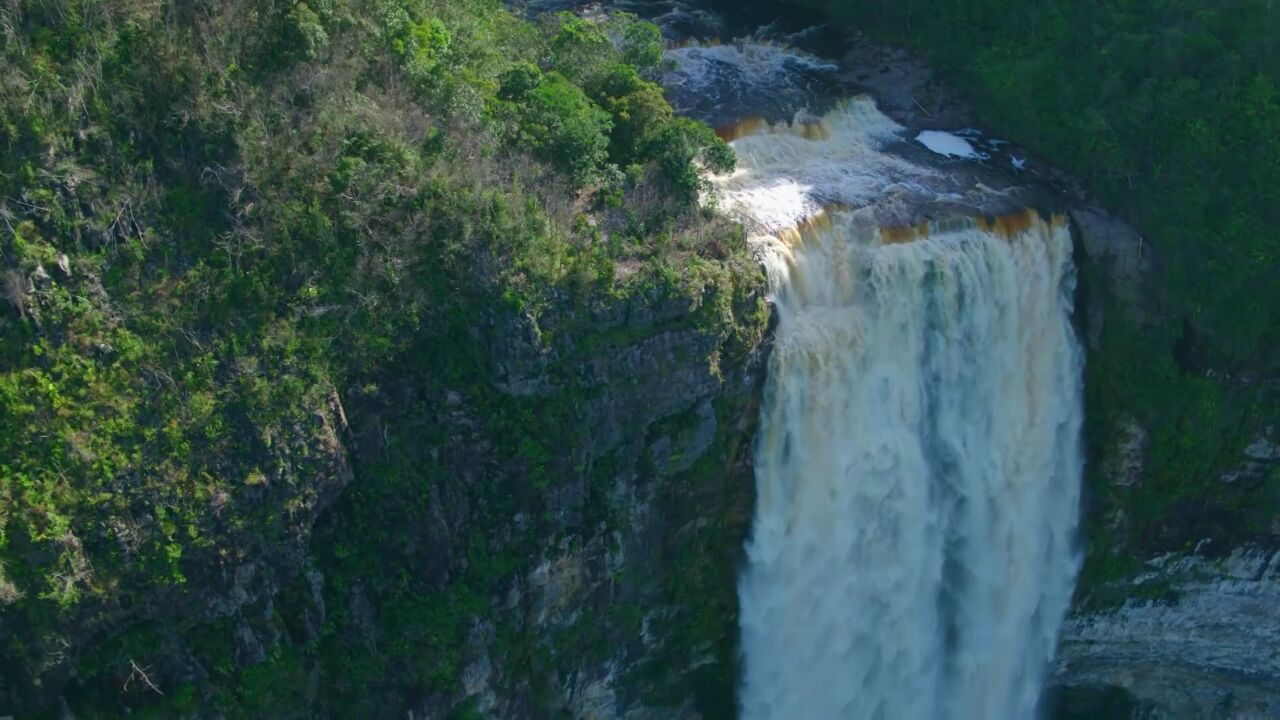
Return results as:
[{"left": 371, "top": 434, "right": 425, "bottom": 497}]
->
[{"left": 399, "top": 266, "right": 767, "bottom": 719}]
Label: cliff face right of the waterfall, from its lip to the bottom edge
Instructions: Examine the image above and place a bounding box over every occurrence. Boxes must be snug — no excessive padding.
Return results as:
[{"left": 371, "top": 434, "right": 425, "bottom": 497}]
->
[{"left": 1052, "top": 197, "right": 1280, "bottom": 719}]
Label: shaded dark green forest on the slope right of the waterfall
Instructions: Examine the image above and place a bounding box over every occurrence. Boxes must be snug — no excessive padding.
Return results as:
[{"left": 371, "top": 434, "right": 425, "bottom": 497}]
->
[{"left": 762, "top": 0, "right": 1280, "bottom": 588}]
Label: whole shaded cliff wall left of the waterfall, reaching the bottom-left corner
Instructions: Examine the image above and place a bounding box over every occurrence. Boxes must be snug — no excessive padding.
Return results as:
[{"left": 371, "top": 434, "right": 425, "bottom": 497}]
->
[{"left": 5, "top": 258, "right": 769, "bottom": 719}]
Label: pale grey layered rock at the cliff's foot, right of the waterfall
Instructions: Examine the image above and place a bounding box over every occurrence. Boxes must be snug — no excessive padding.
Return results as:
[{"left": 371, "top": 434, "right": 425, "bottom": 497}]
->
[{"left": 1056, "top": 547, "right": 1280, "bottom": 719}]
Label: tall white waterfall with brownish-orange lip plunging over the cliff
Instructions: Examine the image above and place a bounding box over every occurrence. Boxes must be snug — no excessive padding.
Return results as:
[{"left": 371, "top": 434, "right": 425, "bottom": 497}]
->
[{"left": 716, "top": 100, "right": 1083, "bottom": 720}]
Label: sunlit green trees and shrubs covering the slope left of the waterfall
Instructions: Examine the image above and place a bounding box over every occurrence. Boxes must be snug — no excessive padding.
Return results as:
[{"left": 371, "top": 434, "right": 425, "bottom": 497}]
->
[{"left": 0, "top": 0, "right": 754, "bottom": 717}]
